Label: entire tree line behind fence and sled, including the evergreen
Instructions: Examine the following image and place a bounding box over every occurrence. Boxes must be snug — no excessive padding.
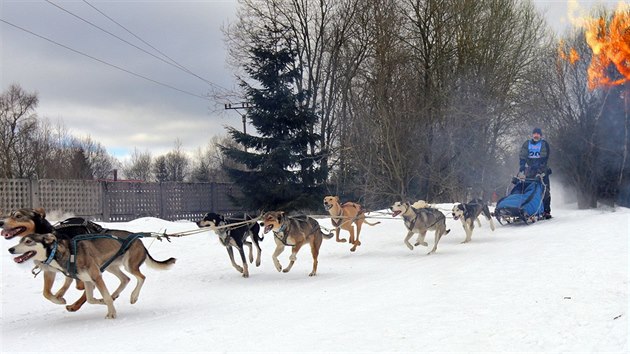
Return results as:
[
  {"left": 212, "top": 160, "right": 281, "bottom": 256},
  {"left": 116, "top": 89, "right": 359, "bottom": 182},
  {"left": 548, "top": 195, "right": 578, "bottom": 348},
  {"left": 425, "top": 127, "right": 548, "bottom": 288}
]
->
[{"left": 0, "top": 0, "right": 630, "bottom": 210}]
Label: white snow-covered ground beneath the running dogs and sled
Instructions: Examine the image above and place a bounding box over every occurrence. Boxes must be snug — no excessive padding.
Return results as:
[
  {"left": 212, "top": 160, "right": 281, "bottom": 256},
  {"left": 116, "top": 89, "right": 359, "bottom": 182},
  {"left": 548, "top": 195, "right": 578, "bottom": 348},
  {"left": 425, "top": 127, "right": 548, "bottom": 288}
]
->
[{"left": 0, "top": 204, "right": 630, "bottom": 353}]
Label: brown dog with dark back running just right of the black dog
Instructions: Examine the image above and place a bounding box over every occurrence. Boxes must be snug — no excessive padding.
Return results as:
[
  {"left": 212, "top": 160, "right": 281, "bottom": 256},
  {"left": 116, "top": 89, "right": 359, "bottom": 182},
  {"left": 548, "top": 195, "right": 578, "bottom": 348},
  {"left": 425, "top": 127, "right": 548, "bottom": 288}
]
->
[{"left": 263, "top": 211, "right": 333, "bottom": 277}]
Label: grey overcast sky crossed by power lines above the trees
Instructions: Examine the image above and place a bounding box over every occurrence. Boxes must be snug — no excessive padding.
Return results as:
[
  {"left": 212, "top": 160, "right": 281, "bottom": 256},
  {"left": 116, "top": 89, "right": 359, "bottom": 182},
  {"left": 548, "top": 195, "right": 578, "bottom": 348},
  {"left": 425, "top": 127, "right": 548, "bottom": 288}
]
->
[{"left": 0, "top": 0, "right": 617, "bottom": 158}]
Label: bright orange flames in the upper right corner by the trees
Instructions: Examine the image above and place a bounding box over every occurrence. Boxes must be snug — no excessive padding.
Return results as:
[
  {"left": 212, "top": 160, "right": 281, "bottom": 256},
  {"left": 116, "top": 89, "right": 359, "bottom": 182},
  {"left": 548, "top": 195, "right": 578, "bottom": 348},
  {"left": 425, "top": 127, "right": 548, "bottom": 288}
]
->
[{"left": 559, "top": 1, "right": 630, "bottom": 90}]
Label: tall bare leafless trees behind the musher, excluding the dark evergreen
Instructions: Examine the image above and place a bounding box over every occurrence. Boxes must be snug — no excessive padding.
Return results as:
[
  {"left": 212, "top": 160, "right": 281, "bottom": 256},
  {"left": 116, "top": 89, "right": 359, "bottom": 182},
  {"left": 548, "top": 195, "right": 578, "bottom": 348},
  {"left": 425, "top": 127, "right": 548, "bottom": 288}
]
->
[{"left": 225, "top": 0, "right": 630, "bottom": 208}]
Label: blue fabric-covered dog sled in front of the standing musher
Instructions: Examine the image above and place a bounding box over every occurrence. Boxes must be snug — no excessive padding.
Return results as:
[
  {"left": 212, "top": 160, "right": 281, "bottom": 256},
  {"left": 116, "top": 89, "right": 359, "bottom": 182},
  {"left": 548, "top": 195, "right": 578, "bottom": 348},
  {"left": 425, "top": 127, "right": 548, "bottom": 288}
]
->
[{"left": 494, "top": 177, "right": 546, "bottom": 225}]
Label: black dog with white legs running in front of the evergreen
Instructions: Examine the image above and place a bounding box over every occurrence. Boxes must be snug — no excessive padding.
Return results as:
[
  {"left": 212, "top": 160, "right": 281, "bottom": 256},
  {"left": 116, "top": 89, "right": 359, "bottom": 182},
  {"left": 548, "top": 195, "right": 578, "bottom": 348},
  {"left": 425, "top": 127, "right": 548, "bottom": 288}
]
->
[{"left": 197, "top": 213, "right": 264, "bottom": 278}]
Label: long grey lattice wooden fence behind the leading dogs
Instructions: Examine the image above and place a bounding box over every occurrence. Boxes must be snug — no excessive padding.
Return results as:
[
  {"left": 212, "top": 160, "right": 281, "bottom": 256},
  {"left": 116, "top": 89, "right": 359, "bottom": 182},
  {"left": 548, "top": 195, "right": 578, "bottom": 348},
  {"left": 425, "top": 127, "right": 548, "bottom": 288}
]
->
[{"left": 0, "top": 179, "right": 243, "bottom": 222}]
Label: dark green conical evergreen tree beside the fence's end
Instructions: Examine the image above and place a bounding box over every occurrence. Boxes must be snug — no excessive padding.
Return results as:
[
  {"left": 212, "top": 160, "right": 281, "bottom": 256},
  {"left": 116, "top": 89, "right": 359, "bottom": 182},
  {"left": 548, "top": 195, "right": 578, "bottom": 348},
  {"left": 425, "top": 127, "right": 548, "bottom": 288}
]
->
[{"left": 222, "top": 29, "right": 325, "bottom": 211}]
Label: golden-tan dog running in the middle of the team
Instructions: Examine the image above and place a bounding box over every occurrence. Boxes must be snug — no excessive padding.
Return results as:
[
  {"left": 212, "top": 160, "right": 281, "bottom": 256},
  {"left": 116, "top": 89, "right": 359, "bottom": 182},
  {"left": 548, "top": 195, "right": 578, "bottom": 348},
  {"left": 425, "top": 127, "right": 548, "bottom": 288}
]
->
[{"left": 324, "top": 195, "right": 380, "bottom": 252}]
